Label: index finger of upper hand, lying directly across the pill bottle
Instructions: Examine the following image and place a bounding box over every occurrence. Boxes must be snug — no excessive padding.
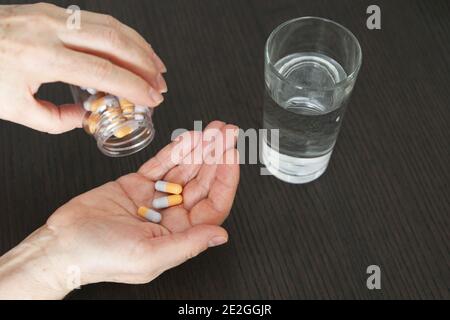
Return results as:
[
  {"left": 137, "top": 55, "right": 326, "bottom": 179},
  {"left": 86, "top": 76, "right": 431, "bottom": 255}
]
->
[{"left": 46, "top": 49, "right": 164, "bottom": 107}]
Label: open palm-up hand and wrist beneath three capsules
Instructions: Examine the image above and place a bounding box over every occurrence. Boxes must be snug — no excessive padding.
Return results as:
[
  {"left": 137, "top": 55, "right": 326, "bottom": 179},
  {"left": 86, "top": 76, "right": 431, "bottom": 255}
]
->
[{"left": 0, "top": 121, "right": 239, "bottom": 298}]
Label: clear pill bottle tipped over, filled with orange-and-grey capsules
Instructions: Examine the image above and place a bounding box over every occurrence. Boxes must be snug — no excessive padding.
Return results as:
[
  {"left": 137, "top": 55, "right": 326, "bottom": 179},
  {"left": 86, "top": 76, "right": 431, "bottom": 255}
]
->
[{"left": 70, "top": 86, "right": 155, "bottom": 157}]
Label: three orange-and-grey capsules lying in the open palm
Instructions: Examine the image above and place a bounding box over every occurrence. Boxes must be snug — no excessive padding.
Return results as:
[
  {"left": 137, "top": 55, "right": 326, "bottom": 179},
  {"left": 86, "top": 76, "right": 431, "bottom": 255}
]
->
[{"left": 138, "top": 180, "right": 183, "bottom": 223}]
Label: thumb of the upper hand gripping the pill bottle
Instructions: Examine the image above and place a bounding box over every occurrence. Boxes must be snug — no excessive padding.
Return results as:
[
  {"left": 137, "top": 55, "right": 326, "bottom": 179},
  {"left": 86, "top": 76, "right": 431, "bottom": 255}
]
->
[{"left": 20, "top": 100, "right": 85, "bottom": 134}]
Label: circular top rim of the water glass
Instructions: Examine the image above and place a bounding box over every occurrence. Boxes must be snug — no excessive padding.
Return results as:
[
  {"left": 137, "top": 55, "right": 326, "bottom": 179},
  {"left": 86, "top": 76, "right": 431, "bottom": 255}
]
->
[{"left": 264, "top": 16, "right": 362, "bottom": 91}]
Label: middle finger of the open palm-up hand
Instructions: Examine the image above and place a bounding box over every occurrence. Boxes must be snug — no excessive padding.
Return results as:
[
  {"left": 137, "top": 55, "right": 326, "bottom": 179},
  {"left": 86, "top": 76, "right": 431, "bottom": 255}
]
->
[{"left": 183, "top": 125, "right": 238, "bottom": 210}]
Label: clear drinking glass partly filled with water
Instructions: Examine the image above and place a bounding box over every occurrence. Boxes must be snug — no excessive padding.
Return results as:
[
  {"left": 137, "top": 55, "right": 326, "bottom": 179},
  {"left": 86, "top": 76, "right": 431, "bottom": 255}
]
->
[{"left": 262, "top": 17, "right": 362, "bottom": 183}]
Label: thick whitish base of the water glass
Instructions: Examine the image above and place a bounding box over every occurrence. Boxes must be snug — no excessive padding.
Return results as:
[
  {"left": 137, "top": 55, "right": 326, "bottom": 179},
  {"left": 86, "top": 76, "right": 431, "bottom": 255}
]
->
[{"left": 262, "top": 143, "right": 333, "bottom": 183}]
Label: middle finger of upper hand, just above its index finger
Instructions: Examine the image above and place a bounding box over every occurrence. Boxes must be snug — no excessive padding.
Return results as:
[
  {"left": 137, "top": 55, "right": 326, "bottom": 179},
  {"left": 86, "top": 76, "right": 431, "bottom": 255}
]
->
[{"left": 59, "top": 23, "right": 167, "bottom": 92}]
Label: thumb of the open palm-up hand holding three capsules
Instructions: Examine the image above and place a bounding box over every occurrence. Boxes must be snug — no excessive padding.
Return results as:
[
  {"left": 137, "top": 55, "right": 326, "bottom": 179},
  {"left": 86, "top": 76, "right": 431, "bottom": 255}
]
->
[{"left": 152, "top": 225, "right": 228, "bottom": 272}]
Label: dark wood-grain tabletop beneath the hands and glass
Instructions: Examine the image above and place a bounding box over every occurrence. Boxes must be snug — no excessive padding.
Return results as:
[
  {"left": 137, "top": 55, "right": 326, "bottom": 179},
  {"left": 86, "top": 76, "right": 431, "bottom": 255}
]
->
[{"left": 0, "top": 0, "right": 450, "bottom": 299}]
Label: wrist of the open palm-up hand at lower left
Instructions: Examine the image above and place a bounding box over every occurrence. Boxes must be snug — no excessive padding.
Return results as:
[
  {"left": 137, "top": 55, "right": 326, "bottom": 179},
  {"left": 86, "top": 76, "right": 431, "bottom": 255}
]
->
[{"left": 0, "top": 226, "right": 75, "bottom": 299}]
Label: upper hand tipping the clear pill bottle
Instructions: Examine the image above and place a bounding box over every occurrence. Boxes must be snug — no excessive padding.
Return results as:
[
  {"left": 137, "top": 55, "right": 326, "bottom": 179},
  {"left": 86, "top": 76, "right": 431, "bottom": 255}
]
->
[{"left": 0, "top": 3, "right": 167, "bottom": 133}]
